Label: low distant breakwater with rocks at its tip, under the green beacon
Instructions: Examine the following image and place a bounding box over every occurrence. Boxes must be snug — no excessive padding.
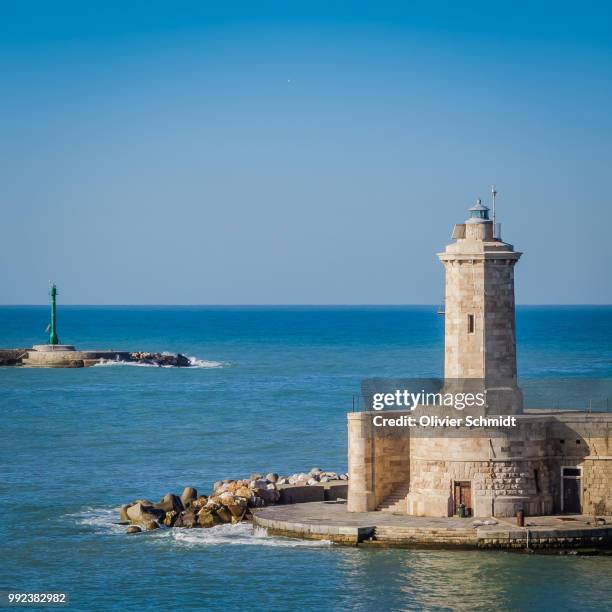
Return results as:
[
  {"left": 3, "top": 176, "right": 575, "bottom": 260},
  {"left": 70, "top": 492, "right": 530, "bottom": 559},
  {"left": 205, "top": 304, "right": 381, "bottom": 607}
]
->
[{"left": 0, "top": 344, "right": 193, "bottom": 368}]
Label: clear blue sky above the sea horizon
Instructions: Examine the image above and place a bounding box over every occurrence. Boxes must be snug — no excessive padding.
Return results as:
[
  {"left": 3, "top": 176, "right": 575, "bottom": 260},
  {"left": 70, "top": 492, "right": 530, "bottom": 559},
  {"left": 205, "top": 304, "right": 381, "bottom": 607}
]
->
[{"left": 0, "top": 0, "right": 612, "bottom": 304}]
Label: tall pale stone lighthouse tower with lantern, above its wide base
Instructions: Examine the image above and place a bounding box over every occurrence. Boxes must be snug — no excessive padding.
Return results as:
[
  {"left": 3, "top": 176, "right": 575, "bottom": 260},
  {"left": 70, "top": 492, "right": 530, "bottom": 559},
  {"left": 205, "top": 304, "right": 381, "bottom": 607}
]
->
[{"left": 438, "top": 200, "right": 523, "bottom": 414}]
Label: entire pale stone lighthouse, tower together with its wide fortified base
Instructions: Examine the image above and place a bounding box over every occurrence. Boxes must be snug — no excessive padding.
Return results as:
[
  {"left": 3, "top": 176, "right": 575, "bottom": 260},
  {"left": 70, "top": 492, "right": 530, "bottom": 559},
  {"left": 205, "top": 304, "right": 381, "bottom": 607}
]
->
[{"left": 348, "top": 201, "right": 612, "bottom": 517}]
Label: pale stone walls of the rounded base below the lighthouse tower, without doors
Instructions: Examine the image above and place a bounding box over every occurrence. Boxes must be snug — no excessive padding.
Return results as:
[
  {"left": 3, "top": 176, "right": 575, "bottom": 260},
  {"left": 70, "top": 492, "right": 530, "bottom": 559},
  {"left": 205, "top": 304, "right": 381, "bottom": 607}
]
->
[{"left": 348, "top": 411, "right": 612, "bottom": 517}]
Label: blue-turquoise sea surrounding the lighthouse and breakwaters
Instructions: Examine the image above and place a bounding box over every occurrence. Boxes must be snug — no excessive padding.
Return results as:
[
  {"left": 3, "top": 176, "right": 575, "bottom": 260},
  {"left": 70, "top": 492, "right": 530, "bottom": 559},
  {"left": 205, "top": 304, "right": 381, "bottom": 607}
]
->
[{"left": 0, "top": 307, "right": 612, "bottom": 611}]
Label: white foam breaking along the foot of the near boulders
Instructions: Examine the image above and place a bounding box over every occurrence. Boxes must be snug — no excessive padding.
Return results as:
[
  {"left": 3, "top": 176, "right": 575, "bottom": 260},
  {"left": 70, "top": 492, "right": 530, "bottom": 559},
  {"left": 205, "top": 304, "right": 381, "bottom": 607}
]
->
[{"left": 66, "top": 507, "right": 332, "bottom": 548}]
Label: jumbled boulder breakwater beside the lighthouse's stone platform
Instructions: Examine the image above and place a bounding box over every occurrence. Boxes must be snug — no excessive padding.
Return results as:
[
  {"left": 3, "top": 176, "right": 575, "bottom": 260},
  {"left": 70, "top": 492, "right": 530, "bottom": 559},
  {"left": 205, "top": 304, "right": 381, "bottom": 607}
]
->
[{"left": 119, "top": 468, "right": 348, "bottom": 533}]
